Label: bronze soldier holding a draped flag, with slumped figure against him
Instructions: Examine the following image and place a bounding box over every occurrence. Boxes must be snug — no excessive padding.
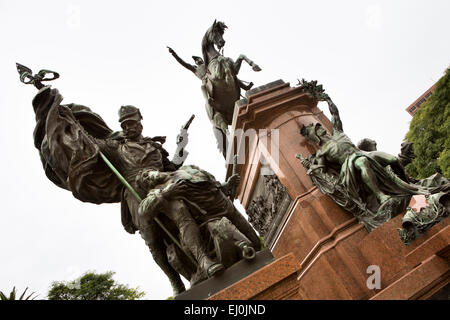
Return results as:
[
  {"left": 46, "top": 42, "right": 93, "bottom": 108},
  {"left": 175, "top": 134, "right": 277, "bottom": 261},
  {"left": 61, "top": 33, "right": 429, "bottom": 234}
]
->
[{"left": 17, "top": 65, "right": 259, "bottom": 294}]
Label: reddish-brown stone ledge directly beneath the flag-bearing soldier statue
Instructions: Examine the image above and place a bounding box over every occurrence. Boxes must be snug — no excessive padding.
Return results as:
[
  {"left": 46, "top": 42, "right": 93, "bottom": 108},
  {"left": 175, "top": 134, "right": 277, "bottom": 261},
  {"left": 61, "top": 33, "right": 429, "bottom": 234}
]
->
[{"left": 208, "top": 253, "right": 300, "bottom": 300}]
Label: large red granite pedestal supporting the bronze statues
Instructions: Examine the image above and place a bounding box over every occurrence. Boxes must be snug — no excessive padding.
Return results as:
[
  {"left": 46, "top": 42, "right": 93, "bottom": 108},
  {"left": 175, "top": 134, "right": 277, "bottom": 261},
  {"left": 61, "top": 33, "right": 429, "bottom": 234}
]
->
[{"left": 224, "top": 81, "right": 450, "bottom": 299}]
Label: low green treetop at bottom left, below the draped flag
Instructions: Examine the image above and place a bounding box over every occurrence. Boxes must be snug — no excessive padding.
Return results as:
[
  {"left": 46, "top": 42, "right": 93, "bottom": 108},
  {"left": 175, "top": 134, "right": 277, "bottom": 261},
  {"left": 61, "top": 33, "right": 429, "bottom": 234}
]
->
[{"left": 48, "top": 271, "right": 145, "bottom": 300}]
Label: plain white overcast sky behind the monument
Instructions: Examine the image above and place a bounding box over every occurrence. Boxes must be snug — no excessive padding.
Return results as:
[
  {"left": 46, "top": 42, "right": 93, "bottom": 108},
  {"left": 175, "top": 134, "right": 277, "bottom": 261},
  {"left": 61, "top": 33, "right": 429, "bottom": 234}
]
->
[{"left": 0, "top": 0, "right": 450, "bottom": 299}]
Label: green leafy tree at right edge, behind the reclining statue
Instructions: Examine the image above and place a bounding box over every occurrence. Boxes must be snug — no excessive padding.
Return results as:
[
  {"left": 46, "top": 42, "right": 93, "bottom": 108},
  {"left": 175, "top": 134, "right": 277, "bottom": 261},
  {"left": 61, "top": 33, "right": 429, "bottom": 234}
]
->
[{"left": 406, "top": 68, "right": 450, "bottom": 179}]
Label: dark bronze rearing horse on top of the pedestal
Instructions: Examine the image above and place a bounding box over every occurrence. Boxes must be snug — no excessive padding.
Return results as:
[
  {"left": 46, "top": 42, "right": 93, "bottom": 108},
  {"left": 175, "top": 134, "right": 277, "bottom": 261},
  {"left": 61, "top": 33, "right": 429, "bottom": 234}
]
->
[{"left": 202, "top": 20, "right": 261, "bottom": 158}]
